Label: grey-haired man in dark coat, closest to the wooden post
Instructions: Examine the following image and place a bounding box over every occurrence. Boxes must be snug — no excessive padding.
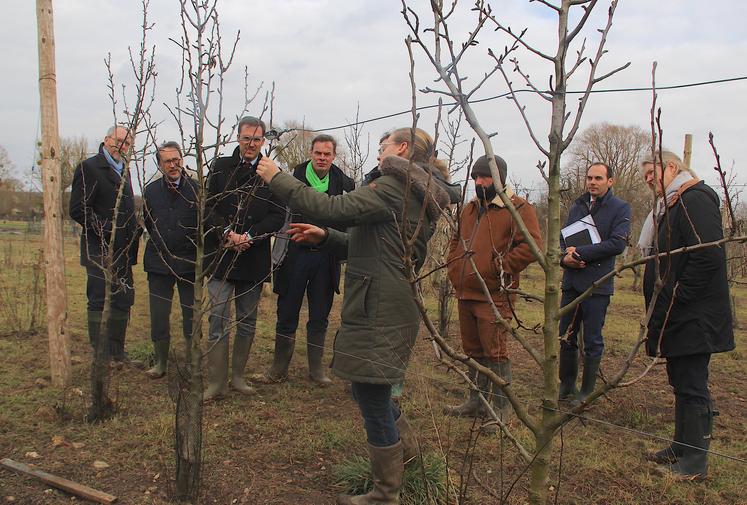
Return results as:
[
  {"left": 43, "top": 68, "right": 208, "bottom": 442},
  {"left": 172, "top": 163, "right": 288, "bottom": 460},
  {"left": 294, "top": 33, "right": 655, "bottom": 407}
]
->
[{"left": 70, "top": 126, "right": 141, "bottom": 363}]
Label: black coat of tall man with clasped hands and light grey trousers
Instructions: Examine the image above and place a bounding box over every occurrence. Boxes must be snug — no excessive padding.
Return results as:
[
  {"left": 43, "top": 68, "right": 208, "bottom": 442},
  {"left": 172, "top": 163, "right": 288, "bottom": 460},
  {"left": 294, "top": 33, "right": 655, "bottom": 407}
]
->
[{"left": 205, "top": 147, "right": 285, "bottom": 283}]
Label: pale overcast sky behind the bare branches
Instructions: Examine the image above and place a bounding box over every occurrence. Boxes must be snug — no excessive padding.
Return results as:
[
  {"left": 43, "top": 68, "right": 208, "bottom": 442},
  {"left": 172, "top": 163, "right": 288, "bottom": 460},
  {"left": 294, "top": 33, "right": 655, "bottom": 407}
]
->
[{"left": 5, "top": 0, "right": 747, "bottom": 196}]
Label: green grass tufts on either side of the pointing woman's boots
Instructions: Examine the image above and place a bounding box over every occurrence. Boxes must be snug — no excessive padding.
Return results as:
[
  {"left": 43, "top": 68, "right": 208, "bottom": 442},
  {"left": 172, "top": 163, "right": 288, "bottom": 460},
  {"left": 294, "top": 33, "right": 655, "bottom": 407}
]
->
[{"left": 333, "top": 454, "right": 446, "bottom": 505}]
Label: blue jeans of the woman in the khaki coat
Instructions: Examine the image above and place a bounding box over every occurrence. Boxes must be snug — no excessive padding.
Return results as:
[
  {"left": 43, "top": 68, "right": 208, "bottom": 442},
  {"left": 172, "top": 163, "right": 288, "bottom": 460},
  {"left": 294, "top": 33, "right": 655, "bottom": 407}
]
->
[{"left": 351, "top": 382, "right": 400, "bottom": 447}]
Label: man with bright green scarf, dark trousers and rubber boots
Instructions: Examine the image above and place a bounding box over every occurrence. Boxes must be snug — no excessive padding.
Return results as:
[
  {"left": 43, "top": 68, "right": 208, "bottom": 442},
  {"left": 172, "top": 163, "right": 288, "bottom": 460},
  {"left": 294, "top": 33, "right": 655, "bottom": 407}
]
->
[{"left": 265, "top": 134, "right": 355, "bottom": 385}]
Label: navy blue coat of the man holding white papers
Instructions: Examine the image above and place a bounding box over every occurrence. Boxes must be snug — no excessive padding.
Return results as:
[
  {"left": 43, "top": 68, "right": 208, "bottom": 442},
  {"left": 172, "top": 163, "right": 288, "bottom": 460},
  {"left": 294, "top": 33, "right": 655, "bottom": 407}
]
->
[{"left": 560, "top": 188, "right": 630, "bottom": 295}]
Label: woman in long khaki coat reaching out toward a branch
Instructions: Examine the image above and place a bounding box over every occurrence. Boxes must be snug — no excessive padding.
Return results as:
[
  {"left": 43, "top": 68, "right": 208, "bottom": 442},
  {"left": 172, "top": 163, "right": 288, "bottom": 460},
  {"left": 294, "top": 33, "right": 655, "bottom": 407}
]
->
[{"left": 257, "top": 128, "right": 449, "bottom": 505}]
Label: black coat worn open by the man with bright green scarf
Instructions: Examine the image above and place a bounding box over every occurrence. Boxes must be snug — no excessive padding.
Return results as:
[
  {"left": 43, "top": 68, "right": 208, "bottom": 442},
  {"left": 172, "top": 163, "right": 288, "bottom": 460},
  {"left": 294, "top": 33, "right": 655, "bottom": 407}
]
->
[{"left": 273, "top": 160, "right": 355, "bottom": 295}]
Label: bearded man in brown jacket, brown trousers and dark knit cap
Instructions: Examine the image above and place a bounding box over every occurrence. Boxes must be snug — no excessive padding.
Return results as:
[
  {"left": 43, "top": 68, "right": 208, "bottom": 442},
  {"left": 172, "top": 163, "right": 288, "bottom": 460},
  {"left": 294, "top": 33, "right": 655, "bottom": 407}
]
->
[{"left": 445, "top": 156, "right": 542, "bottom": 421}]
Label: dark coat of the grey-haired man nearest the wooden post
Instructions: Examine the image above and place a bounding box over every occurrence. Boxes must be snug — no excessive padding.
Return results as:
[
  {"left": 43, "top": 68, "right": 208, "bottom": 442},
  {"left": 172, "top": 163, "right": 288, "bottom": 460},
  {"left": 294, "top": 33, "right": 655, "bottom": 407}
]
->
[{"left": 70, "top": 144, "right": 142, "bottom": 266}]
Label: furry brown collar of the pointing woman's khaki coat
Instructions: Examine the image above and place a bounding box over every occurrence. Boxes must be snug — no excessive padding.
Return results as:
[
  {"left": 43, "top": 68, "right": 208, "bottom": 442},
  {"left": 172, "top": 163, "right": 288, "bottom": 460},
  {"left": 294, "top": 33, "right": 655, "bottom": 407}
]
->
[{"left": 379, "top": 155, "right": 449, "bottom": 221}]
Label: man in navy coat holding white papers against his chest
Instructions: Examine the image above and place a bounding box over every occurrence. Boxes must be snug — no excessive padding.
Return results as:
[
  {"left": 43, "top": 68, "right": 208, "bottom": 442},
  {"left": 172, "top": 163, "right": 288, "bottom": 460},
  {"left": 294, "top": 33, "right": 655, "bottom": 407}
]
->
[{"left": 558, "top": 163, "right": 630, "bottom": 402}]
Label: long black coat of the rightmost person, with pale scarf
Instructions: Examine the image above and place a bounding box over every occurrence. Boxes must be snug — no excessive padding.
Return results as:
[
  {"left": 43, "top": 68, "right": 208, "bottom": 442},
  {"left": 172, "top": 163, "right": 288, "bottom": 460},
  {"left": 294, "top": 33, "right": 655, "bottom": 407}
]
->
[{"left": 643, "top": 181, "right": 734, "bottom": 358}]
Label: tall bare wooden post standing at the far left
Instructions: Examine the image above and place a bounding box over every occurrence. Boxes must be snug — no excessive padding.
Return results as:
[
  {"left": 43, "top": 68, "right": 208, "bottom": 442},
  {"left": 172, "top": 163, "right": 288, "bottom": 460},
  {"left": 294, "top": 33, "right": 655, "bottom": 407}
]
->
[{"left": 36, "top": 0, "right": 71, "bottom": 387}]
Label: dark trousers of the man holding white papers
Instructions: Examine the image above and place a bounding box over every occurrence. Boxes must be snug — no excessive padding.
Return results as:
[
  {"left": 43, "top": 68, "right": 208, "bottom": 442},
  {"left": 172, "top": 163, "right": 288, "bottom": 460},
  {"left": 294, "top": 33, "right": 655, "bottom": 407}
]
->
[{"left": 560, "top": 289, "right": 610, "bottom": 358}]
